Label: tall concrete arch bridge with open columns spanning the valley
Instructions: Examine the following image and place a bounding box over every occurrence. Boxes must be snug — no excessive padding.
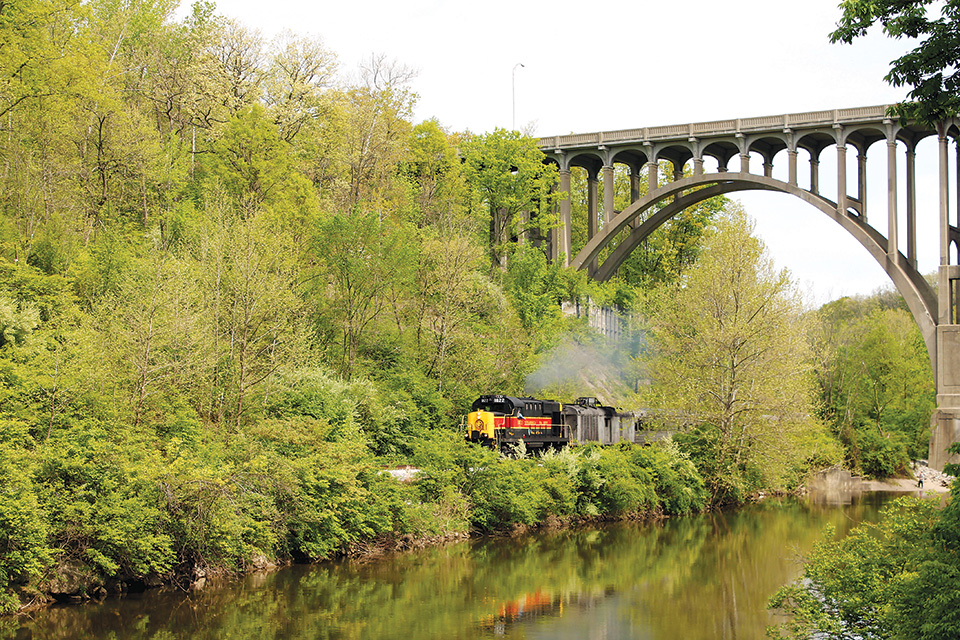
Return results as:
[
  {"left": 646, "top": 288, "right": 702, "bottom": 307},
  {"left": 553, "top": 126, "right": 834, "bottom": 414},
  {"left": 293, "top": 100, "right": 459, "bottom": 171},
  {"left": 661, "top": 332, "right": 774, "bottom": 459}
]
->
[{"left": 539, "top": 106, "right": 960, "bottom": 469}]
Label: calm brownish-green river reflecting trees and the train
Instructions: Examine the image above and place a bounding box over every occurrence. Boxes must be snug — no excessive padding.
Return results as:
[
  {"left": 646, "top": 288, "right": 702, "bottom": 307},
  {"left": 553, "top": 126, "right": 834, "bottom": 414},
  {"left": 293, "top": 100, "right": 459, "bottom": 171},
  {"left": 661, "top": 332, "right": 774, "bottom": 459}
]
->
[{"left": 0, "top": 494, "right": 885, "bottom": 640}]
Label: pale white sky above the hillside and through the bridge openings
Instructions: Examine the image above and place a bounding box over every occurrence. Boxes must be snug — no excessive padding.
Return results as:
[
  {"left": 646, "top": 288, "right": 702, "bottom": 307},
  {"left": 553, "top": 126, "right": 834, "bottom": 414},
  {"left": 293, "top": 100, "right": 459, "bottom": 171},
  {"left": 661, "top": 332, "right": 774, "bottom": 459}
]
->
[{"left": 189, "top": 0, "right": 939, "bottom": 304}]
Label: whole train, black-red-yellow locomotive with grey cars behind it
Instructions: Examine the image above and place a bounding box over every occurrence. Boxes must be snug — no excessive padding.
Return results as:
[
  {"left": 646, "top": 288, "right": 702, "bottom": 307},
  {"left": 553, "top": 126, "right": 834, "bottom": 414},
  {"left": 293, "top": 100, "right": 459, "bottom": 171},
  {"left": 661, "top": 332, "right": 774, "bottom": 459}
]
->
[{"left": 466, "top": 395, "right": 643, "bottom": 451}]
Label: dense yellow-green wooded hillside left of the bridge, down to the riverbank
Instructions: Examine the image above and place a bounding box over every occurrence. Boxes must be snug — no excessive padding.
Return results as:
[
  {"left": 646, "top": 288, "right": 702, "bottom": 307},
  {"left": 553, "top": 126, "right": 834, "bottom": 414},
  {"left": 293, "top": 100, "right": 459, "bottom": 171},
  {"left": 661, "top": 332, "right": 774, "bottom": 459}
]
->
[{"left": 0, "top": 0, "right": 736, "bottom": 610}]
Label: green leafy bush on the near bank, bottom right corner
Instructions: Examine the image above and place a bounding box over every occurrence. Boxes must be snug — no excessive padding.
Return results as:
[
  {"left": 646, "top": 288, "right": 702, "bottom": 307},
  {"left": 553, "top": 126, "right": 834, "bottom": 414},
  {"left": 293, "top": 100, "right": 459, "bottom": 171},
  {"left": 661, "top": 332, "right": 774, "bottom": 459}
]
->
[{"left": 770, "top": 496, "right": 960, "bottom": 640}]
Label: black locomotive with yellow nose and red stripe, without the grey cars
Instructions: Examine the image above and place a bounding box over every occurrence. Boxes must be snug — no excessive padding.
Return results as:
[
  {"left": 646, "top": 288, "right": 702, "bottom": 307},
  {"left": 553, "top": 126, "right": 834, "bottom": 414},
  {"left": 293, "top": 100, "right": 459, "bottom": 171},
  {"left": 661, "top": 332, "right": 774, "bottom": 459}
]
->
[{"left": 467, "top": 396, "right": 570, "bottom": 449}]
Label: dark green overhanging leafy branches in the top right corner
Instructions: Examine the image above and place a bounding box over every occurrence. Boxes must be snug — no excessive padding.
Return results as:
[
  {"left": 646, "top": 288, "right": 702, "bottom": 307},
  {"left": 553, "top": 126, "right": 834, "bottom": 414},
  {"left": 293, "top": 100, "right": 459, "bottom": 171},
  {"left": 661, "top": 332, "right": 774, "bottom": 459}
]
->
[{"left": 830, "top": 0, "right": 960, "bottom": 124}]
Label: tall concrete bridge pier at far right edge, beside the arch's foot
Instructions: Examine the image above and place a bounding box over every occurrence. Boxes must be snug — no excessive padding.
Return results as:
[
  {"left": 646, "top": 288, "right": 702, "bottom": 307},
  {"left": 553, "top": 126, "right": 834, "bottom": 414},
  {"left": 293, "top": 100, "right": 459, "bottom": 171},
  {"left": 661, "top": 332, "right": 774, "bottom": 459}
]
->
[{"left": 929, "top": 123, "right": 960, "bottom": 470}]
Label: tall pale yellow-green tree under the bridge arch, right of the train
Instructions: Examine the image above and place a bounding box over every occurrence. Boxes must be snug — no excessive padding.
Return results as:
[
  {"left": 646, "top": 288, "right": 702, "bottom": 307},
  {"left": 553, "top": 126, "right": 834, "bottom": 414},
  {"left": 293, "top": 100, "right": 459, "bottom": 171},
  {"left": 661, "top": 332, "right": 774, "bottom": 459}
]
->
[{"left": 650, "top": 210, "right": 835, "bottom": 502}]
